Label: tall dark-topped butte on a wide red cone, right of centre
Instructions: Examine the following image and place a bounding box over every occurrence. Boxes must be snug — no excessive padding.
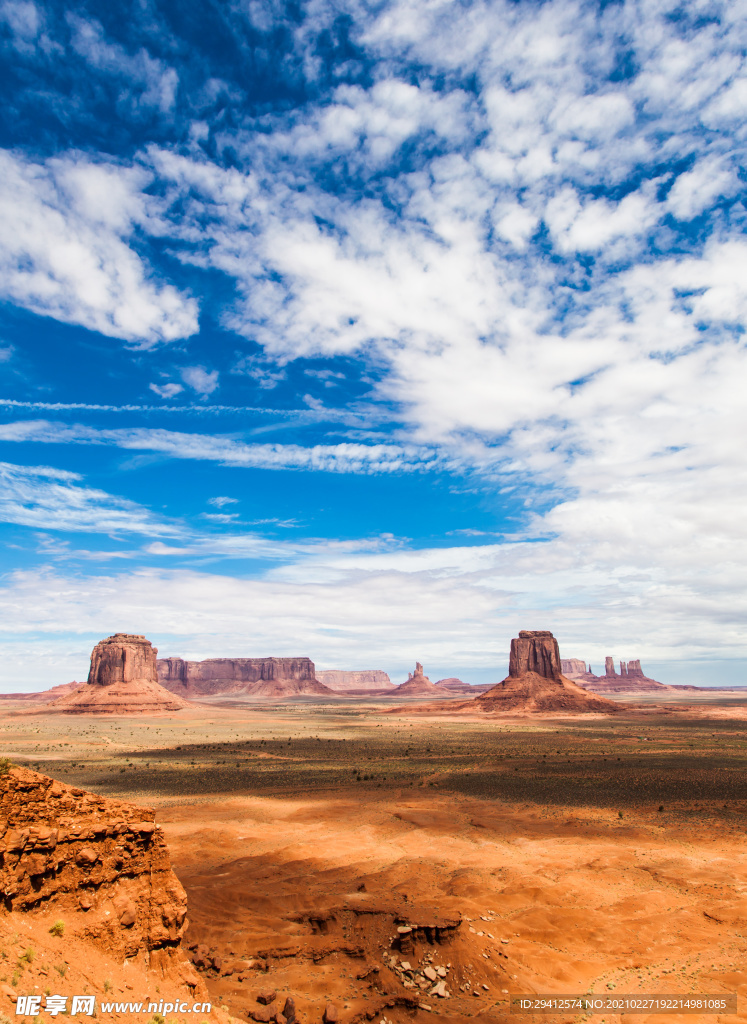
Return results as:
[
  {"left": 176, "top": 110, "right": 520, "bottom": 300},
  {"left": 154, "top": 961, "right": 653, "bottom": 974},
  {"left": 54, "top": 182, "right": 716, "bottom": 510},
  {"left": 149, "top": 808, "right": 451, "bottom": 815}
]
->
[{"left": 466, "top": 630, "right": 620, "bottom": 715}]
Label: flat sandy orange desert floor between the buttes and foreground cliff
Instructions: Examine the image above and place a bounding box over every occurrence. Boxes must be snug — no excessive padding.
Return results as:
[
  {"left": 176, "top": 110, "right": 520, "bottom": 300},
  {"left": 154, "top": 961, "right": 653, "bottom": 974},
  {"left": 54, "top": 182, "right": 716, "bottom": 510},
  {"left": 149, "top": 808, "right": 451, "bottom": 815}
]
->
[{"left": 0, "top": 701, "right": 747, "bottom": 1024}]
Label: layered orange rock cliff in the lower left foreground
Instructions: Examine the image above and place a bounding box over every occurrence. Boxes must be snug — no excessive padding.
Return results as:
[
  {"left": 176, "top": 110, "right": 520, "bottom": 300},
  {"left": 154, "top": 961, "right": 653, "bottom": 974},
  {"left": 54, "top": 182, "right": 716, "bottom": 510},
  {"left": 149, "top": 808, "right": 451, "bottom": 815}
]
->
[{"left": 0, "top": 768, "right": 190, "bottom": 966}]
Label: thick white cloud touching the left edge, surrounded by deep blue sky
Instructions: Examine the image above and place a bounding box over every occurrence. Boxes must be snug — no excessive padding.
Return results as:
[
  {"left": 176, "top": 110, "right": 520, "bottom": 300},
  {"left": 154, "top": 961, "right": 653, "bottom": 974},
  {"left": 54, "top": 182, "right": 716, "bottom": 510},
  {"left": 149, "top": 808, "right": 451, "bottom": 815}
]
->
[{"left": 0, "top": 152, "right": 197, "bottom": 348}]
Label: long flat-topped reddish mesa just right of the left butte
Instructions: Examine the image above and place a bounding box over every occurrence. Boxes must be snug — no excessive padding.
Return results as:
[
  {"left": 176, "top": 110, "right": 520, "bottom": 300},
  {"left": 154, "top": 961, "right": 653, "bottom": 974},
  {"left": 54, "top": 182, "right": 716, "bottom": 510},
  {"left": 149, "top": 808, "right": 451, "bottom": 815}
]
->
[{"left": 157, "top": 657, "right": 333, "bottom": 696}]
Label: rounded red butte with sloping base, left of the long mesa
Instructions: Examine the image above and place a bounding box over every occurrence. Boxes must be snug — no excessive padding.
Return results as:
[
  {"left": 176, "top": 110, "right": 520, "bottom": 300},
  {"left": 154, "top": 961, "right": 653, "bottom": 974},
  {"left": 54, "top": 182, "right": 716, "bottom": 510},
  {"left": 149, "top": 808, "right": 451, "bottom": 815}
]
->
[{"left": 43, "top": 633, "right": 192, "bottom": 715}]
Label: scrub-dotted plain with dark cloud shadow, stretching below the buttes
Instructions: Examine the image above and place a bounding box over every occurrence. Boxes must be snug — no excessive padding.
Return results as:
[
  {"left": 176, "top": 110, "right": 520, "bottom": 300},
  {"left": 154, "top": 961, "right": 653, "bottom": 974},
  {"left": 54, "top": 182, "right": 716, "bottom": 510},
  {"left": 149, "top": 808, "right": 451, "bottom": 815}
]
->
[{"left": 27, "top": 701, "right": 747, "bottom": 815}]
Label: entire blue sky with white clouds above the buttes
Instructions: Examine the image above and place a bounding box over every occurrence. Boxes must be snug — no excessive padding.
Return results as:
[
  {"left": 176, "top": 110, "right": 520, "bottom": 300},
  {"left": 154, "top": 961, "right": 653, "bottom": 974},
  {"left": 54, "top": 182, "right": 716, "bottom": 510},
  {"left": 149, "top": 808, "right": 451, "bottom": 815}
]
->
[{"left": 0, "top": 0, "right": 747, "bottom": 689}]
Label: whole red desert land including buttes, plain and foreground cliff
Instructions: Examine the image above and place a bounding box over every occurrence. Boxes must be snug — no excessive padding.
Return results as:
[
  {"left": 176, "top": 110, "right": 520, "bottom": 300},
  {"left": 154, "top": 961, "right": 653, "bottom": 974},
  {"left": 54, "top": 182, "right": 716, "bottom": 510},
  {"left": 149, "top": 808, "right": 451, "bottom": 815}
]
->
[{"left": 0, "top": 631, "right": 747, "bottom": 1024}]
